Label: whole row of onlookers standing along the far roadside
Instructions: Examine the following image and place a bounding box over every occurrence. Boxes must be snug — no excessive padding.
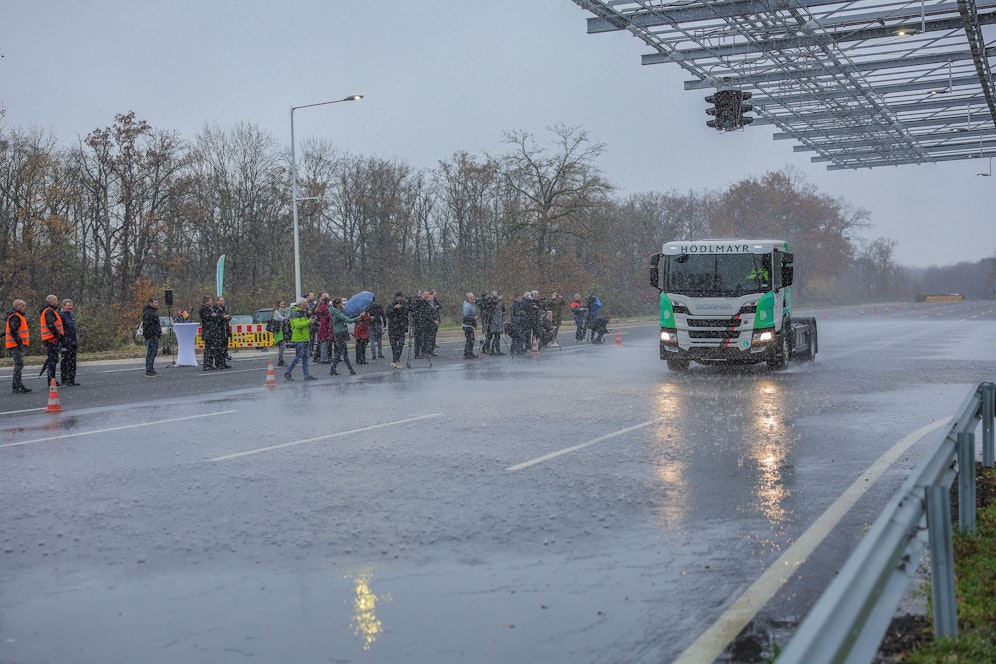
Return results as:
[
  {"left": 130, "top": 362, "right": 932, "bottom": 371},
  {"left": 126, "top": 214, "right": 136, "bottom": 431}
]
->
[{"left": 5, "top": 290, "right": 610, "bottom": 394}]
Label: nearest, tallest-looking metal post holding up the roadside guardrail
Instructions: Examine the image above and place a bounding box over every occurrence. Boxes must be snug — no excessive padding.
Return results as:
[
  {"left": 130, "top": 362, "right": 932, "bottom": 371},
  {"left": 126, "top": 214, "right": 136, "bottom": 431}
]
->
[{"left": 924, "top": 486, "right": 958, "bottom": 639}]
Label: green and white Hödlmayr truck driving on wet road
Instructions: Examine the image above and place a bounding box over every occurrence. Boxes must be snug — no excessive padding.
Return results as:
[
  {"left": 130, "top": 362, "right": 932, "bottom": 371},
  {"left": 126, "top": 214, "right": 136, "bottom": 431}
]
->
[{"left": 650, "top": 239, "right": 818, "bottom": 371}]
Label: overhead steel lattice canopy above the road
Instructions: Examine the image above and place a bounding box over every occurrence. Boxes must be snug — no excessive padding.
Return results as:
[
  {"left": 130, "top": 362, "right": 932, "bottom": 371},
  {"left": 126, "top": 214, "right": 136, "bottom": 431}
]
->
[{"left": 573, "top": 0, "right": 996, "bottom": 170}]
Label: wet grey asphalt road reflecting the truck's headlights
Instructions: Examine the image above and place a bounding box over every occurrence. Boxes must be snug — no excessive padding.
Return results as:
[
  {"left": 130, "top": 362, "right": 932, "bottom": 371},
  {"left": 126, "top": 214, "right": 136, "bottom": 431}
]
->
[{"left": 0, "top": 302, "right": 996, "bottom": 664}]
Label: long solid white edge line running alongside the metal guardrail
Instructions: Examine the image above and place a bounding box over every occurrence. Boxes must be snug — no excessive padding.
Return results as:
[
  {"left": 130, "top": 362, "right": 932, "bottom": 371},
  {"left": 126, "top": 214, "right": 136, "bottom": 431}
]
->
[{"left": 674, "top": 419, "right": 951, "bottom": 664}]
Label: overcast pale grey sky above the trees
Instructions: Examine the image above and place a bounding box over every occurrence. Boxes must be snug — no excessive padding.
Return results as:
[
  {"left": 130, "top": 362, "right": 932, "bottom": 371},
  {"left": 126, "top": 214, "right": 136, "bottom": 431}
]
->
[{"left": 0, "top": 0, "right": 996, "bottom": 266}]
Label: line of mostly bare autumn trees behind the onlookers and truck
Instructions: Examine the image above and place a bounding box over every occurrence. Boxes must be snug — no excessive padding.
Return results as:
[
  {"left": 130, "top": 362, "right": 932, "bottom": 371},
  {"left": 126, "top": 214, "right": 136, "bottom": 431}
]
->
[{"left": 0, "top": 113, "right": 976, "bottom": 356}]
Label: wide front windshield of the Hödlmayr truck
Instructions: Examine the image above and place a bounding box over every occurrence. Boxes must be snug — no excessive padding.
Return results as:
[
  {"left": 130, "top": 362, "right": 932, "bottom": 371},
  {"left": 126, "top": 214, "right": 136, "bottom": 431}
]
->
[{"left": 664, "top": 254, "right": 771, "bottom": 297}]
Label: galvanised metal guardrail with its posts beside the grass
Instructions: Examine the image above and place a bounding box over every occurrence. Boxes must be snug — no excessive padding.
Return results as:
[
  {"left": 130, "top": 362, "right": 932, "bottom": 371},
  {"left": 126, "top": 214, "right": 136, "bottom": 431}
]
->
[{"left": 776, "top": 383, "right": 996, "bottom": 664}]
